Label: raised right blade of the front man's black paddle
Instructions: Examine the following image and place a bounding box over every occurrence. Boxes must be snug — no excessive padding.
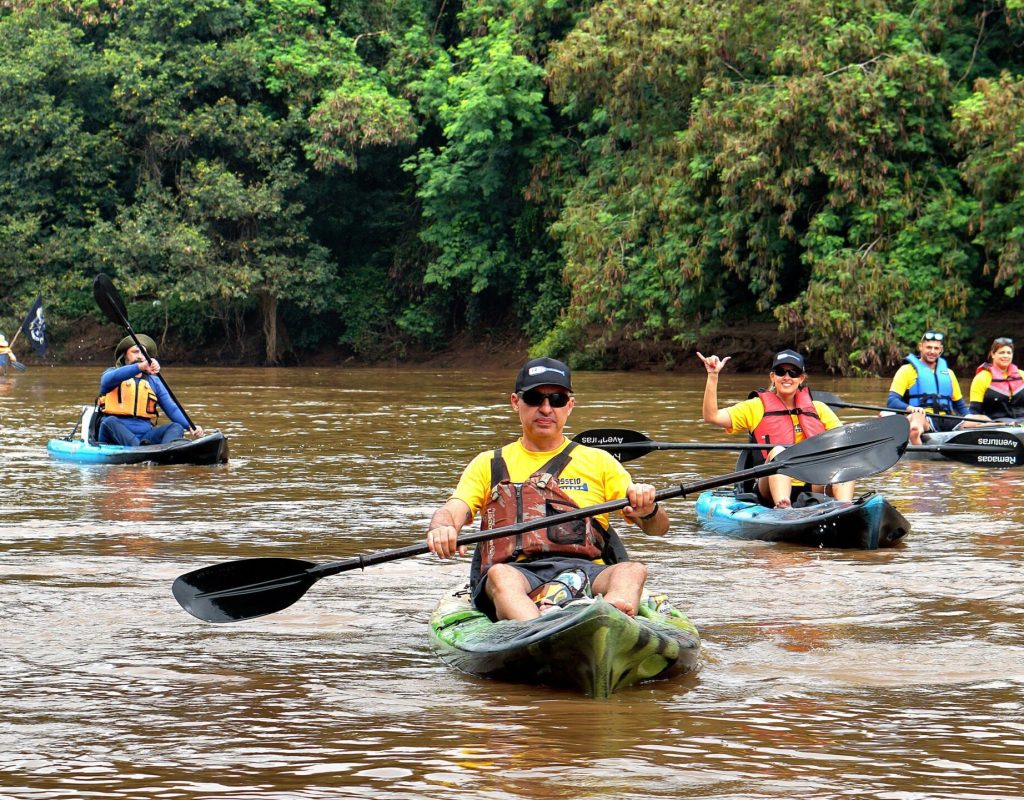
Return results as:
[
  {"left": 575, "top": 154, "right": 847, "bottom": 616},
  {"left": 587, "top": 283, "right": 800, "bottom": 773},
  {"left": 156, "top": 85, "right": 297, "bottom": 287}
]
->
[{"left": 771, "top": 416, "right": 910, "bottom": 483}]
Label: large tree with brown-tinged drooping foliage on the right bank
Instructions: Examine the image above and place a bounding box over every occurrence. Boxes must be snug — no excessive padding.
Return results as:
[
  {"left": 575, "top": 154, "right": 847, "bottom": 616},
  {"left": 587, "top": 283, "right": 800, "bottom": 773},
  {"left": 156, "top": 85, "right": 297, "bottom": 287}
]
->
[{"left": 549, "top": 0, "right": 1015, "bottom": 371}]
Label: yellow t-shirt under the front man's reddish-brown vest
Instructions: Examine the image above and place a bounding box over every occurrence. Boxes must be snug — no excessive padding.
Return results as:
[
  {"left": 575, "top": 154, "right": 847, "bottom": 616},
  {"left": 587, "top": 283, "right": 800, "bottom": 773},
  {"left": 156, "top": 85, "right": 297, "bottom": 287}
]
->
[{"left": 452, "top": 439, "right": 633, "bottom": 528}]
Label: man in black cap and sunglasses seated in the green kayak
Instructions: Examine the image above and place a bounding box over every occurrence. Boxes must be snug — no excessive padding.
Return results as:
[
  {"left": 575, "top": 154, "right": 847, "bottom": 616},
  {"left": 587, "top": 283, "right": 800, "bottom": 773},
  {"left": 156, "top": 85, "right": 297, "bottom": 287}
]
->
[{"left": 427, "top": 359, "right": 669, "bottom": 620}]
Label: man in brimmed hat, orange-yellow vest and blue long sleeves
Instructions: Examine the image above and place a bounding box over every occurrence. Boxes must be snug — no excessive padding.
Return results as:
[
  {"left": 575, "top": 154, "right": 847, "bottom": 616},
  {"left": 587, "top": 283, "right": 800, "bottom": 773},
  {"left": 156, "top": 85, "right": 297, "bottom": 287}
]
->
[{"left": 97, "top": 334, "right": 203, "bottom": 447}]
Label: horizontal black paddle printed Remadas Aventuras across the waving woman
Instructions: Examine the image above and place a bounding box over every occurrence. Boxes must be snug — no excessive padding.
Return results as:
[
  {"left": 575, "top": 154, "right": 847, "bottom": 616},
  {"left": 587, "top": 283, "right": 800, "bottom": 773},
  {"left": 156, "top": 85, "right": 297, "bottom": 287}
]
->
[{"left": 572, "top": 424, "right": 1024, "bottom": 469}]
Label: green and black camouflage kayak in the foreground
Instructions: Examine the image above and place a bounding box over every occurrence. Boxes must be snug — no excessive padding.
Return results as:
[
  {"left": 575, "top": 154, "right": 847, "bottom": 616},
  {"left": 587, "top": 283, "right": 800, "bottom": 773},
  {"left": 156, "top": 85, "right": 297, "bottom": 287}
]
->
[{"left": 430, "top": 587, "right": 700, "bottom": 698}]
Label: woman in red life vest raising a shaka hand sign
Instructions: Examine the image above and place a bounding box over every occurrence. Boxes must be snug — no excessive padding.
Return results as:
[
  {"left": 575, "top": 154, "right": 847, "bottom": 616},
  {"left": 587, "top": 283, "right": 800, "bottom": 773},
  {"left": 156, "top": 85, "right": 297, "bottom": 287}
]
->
[{"left": 697, "top": 350, "right": 854, "bottom": 508}]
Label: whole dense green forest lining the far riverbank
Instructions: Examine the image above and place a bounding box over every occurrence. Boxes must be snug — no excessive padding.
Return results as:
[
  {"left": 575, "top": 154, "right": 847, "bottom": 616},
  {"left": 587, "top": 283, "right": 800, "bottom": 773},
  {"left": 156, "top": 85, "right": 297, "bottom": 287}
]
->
[{"left": 0, "top": 0, "right": 1024, "bottom": 374}]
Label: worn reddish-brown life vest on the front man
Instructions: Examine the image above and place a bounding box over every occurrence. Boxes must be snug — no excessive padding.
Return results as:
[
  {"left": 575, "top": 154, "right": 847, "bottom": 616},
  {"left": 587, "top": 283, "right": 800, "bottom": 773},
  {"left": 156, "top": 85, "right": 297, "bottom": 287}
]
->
[{"left": 470, "top": 441, "right": 613, "bottom": 586}]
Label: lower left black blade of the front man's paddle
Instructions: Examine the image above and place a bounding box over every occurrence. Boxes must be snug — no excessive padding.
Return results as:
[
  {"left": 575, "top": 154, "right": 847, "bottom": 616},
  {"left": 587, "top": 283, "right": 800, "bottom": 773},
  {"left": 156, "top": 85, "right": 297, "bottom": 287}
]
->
[{"left": 171, "top": 558, "right": 321, "bottom": 622}]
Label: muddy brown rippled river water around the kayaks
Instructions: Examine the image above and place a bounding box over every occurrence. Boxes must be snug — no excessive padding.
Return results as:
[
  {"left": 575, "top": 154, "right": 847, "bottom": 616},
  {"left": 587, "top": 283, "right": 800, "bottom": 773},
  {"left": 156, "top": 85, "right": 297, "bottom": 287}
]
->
[{"left": 0, "top": 365, "right": 1024, "bottom": 800}]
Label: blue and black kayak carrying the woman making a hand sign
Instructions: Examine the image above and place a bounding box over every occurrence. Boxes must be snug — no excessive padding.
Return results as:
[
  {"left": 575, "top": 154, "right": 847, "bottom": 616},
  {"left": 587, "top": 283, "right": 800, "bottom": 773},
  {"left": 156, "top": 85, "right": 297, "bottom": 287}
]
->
[{"left": 696, "top": 490, "right": 910, "bottom": 550}]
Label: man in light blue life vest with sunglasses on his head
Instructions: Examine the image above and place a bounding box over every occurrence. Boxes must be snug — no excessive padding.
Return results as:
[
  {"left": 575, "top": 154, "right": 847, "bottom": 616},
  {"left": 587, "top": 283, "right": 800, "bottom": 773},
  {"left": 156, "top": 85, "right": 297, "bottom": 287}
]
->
[{"left": 886, "top": 331, "right": 971, "bottom": 445}]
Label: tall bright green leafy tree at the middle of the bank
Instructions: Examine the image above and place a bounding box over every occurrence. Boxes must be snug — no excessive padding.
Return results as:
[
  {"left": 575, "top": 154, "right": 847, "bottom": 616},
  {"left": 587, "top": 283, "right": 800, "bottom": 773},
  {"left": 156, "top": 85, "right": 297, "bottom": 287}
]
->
[{"left": 401, "top": 0, "right": 577, "bottom": 344}]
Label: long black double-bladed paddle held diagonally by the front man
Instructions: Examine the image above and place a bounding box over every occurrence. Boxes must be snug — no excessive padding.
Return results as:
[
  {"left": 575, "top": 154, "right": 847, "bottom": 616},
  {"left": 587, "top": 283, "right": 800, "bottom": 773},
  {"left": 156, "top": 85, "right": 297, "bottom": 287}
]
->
[{"left": 171, "top": 416, "right": 909, "bottom": 623}]
